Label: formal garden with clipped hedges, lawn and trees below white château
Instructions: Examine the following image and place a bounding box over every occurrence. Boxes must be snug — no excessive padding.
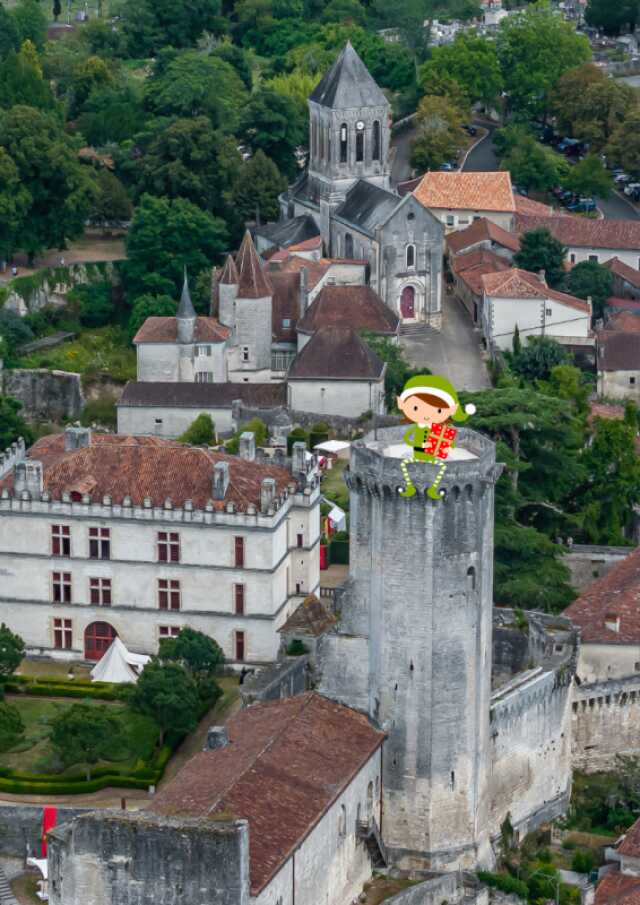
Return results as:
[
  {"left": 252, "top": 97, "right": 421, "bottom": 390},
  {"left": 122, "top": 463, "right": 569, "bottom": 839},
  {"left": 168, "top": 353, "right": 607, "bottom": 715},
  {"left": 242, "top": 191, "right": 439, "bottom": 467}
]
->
[{"left": 0, "top": 625, "right": 237, "bottom": 795}]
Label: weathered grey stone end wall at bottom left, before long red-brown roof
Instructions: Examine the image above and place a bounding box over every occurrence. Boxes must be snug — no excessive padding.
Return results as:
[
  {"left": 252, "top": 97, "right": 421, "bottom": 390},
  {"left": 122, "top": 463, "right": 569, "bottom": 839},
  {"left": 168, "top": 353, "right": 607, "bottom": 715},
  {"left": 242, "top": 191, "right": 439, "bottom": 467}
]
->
[{"left": 49, "top": 811, "right": 250, "bottom": 905}]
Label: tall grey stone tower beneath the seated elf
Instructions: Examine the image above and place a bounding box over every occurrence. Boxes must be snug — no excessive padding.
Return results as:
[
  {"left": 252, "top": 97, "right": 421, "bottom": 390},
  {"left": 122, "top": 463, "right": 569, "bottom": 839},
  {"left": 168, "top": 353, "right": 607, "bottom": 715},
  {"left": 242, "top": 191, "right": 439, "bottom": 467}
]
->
[{"left": 320, "top": 428, "right": 501, "bottom": 868}]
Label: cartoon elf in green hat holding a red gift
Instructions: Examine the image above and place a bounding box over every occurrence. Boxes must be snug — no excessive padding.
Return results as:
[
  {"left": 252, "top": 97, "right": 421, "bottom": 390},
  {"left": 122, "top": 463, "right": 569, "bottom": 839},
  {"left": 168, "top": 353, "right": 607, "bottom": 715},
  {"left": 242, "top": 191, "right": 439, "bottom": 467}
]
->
[{"left": 397, "top": 374, "right": 476, "bottom": 500}]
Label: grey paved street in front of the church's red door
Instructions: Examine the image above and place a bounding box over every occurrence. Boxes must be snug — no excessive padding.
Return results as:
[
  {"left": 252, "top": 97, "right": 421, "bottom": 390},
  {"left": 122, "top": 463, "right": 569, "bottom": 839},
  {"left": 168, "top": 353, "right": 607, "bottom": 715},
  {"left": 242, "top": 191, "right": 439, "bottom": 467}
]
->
[{"left": 400, "top": 293, "right": 491, "bottom": 390}]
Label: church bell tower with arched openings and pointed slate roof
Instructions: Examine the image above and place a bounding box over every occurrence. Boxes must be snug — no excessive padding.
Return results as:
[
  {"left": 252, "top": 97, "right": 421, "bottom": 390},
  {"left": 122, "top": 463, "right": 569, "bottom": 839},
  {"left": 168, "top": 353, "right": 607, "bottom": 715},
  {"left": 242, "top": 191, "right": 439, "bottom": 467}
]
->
[{"left": 309, "top": 42, "right": 391, "bottom": 204}]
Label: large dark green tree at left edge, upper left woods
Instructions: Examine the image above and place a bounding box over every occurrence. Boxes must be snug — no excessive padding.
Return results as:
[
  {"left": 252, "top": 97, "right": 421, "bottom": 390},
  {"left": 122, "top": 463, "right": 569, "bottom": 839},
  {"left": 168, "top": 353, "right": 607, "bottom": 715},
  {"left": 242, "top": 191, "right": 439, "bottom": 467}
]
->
[{"left": 0, "top": 106, "right": 96, "bottom": 260}]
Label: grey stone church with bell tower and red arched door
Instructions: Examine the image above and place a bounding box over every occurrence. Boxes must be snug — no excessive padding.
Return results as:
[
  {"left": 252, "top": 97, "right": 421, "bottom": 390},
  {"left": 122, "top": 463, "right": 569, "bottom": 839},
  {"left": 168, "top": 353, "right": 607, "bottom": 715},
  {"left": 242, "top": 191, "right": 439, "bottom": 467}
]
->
[{"left": 256, "top": 43, "right": 444, "bottom": 329}]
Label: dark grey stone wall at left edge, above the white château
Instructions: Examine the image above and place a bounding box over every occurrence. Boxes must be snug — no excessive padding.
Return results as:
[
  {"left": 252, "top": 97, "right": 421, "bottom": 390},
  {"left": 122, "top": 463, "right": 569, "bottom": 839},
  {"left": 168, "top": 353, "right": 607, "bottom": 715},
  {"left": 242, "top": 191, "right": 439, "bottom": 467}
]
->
[{"left": 0, "top": 368, "right": 84, "bottom": 421}]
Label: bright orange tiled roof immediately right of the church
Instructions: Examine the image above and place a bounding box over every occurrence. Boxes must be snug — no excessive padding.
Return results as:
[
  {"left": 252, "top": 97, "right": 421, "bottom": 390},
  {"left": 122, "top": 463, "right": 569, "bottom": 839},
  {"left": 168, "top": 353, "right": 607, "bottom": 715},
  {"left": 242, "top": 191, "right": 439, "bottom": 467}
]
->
[{"left": 413, "top": 170, "right": 516, "bottom": 213}]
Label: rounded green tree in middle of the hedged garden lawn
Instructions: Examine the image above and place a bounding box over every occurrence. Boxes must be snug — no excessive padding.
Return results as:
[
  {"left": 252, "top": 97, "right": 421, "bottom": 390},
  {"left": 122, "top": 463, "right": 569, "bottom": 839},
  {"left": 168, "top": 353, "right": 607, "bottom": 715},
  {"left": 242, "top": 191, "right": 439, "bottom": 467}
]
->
[{"left": 49, "top": 704, "right": 122, "bottom": 780}]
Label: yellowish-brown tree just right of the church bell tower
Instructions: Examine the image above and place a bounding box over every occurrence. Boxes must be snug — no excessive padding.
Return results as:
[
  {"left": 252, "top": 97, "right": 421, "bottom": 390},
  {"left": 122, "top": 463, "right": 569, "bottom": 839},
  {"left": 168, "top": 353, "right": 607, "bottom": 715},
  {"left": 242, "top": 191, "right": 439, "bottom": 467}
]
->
[{"left": 411, "top": 94, "right": 465, "bottom": 172}]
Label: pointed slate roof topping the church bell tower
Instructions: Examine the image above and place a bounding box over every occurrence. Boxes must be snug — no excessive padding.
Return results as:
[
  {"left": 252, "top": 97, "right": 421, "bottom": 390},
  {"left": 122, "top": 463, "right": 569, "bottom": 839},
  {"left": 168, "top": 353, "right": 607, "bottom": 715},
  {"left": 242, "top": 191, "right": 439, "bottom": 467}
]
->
[{"left": 309, "top": 41, "right": 389, "bottom": 110}]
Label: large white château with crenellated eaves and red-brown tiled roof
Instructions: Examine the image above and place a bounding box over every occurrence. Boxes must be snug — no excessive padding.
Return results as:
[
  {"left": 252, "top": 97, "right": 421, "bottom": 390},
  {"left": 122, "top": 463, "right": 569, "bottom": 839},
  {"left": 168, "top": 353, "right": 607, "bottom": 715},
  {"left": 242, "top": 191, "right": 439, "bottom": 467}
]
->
[{"left": 0, "top": 428, "right": 320, "bottom": 662}]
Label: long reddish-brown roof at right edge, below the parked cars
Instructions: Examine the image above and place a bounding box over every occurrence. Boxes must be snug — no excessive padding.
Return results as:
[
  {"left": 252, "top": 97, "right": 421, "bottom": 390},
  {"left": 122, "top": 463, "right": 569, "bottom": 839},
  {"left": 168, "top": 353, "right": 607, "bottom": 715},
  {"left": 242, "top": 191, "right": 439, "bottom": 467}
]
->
[{"left": 516, "top": 214, "right": 640, "bottom": 251}]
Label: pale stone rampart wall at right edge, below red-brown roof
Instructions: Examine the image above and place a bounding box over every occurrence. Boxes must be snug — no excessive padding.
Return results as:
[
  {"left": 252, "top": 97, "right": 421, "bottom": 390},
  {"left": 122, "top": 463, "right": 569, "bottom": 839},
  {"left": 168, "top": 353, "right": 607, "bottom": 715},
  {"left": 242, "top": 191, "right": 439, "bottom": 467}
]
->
[{"left": 571, "top": 675, "right": 640, "bottom": 773}]
